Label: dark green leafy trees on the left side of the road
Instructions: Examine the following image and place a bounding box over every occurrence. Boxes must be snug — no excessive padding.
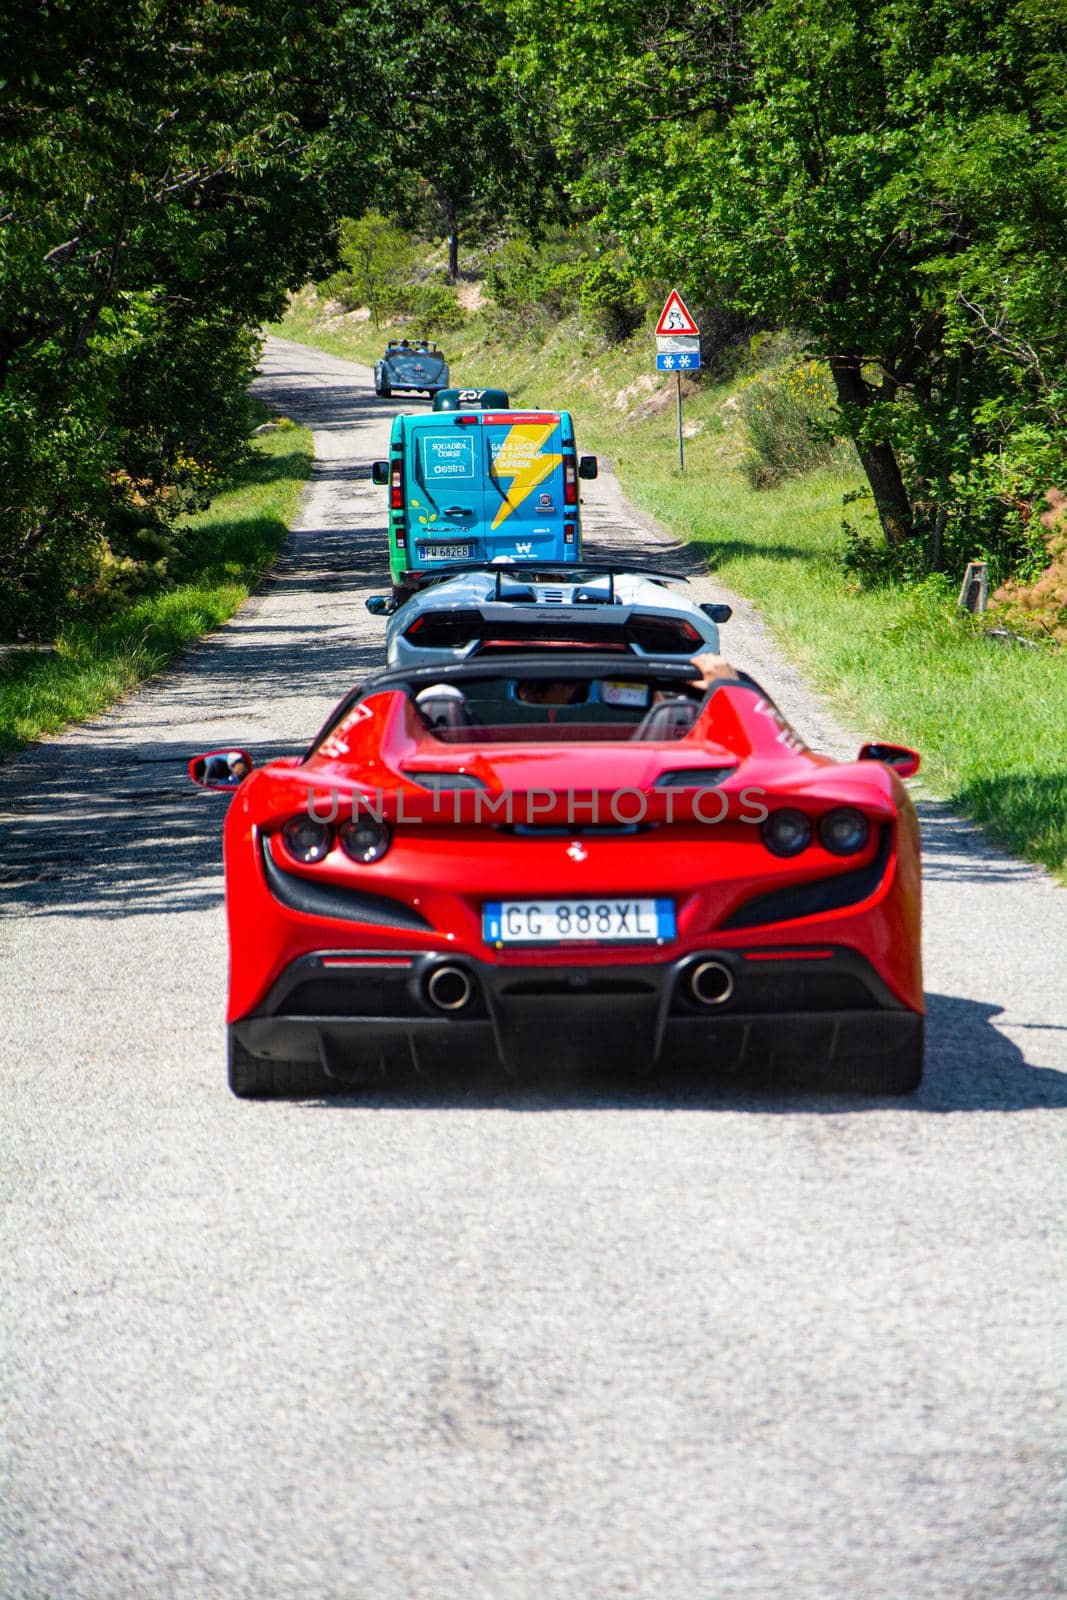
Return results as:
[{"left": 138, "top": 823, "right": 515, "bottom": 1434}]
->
[{"left": 0, "top": 0, "right": 373, "bottom": 629}]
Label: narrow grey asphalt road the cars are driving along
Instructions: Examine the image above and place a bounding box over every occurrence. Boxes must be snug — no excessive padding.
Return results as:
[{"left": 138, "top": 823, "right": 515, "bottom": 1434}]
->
[{"left": 0, "top": 341, "right": 1067, "bottom": 1600}]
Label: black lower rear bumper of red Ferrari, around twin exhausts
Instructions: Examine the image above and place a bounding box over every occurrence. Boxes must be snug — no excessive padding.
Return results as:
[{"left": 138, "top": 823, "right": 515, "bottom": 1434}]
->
[{"left": 230, "top": 947, "right": 923, "bottom": 1091}]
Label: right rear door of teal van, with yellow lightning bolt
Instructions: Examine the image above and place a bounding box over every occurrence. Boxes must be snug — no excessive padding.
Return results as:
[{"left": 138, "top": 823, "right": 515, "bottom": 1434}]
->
[{"left": 482, "top": 411, "right": 577, "bottom": 562}]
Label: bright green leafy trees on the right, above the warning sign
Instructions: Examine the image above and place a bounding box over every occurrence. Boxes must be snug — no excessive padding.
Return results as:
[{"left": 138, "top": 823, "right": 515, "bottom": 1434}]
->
[{"left": 509, "top": 0, "right": 1067, "bottom": 572}]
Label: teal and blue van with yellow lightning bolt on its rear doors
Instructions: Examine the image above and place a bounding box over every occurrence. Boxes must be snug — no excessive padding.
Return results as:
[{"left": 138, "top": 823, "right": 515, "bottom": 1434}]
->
[{"left": 371, "top": 389, "right": 597, "bottom": 594}]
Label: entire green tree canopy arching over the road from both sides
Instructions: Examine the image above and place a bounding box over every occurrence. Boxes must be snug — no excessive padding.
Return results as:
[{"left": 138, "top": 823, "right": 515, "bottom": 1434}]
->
[{"left": 0, "top": 0, "right": 1067, "bottom": 634}]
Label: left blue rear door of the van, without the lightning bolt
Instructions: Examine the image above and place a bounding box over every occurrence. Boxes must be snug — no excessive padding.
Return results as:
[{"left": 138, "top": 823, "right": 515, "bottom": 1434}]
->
[{"left": 405, "top": 411, "right": 486, "bottom": 566}]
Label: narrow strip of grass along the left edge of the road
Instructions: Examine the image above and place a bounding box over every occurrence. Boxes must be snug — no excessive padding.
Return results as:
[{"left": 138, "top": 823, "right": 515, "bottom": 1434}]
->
[{"left": 0, "top": 424, "right": 314, "bottom": 755}]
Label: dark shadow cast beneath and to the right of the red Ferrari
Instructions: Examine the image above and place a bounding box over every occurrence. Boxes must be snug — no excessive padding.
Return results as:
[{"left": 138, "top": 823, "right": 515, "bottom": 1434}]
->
[{"left": 309, "top": 994, "right": 1067, "bottom": 1117}]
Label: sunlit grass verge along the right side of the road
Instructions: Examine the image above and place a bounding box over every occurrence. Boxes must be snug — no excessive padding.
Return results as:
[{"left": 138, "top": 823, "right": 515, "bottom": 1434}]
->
[{"left": 275, "top": 296, "right": 1067, "bottom": 882}]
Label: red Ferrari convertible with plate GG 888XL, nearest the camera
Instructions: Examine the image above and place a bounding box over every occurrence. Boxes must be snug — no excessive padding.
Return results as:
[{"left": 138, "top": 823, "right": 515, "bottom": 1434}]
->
[{"left": 190, "top": 653, "right": 923, "bottom": 1096}]
